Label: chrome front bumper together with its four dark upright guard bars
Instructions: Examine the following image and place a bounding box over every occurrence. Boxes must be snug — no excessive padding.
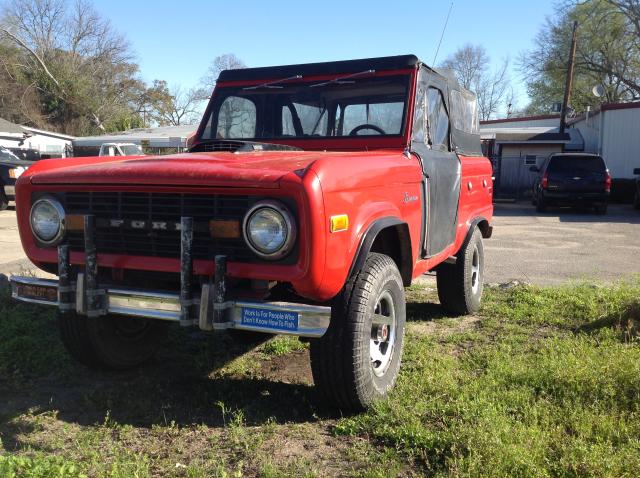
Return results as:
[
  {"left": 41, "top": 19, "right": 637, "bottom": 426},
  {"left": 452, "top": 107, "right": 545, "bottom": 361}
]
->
[{"left": 10, "top": 216, "right": 331, "bottom": 337}]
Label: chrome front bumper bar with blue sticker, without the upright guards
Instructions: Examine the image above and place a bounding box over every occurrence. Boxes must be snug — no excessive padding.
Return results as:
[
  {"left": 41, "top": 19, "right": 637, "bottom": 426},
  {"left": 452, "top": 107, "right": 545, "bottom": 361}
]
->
[{"left": 10, "top": 275, "right": 331, "bottom": 337}]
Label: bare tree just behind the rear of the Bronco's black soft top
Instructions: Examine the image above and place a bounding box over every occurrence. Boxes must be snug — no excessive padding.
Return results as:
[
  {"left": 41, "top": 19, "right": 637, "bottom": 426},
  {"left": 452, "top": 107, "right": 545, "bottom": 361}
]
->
[{"left": 442, "top": 44, "right": 510, "bottom": 120}]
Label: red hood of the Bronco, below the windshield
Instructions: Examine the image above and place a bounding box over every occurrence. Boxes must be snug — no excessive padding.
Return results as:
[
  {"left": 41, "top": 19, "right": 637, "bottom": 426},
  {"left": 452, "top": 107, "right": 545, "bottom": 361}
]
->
[{"left": 30, "top": 151, "right": 326, "bottom": 188}]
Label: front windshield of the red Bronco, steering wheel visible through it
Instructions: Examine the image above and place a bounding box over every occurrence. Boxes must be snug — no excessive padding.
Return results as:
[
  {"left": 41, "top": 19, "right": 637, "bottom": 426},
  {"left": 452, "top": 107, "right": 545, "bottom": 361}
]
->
[{"left": 200, "top": 75, "right": 409, "bottom": 140}]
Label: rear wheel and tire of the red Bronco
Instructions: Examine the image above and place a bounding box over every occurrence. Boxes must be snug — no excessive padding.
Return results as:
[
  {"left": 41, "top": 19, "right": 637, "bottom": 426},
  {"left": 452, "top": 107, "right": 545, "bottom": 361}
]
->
[{"left": 436, "top": 228, "right": 484, "bottom": 315}]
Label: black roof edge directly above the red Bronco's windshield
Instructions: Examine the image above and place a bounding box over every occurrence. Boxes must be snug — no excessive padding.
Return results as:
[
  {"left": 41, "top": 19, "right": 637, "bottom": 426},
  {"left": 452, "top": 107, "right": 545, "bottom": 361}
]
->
[{"left": 218, "top": 55, "right": 420, "bottom": 81}]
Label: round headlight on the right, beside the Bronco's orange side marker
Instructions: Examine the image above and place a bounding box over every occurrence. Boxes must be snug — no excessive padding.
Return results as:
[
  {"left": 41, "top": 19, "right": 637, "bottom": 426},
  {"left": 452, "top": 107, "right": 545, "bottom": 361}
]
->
[{"left": 243, "top": 201, "right": 296, "bottom": 260}]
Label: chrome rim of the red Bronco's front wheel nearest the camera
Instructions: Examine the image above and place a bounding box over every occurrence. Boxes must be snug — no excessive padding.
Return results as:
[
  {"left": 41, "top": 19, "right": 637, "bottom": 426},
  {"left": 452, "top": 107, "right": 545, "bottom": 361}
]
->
[{"left": 369, "top": 290, "right": 396, "bottom": 377}]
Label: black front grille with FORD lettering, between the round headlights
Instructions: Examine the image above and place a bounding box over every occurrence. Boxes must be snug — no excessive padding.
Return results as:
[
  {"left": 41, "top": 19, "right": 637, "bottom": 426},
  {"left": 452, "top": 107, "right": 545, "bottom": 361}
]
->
[{"left": 61, "top": 192, "right": 291, "bottom": 263}]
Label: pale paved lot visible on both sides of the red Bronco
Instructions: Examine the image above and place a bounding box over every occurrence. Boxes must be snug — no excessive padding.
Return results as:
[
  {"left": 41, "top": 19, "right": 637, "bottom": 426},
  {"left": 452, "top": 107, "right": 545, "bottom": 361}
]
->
[{"left": 0, "top": 204, "right": 640, "bottom": 284}]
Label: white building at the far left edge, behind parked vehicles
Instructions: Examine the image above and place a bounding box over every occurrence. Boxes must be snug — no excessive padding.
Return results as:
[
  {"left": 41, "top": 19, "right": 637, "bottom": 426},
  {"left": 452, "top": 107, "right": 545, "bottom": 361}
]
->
[{"left": 0, "top": 118, "right": 74, "bottom": 159}]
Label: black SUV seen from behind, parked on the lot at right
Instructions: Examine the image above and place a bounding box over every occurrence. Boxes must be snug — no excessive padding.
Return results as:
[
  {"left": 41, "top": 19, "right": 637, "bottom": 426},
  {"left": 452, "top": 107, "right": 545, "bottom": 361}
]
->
[{"left": 530, "top": 153, "right": 611, "bottom": 214}]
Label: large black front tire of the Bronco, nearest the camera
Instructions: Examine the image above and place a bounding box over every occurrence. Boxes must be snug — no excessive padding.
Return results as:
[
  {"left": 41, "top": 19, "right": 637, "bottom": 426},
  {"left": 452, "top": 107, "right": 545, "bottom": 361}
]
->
[{"left": 310, "top": 253, "right": 406, "bottom": 412}]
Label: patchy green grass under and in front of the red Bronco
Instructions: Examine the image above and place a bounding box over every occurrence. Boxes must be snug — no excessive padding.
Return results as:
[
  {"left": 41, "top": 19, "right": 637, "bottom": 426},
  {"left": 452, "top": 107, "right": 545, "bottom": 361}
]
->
[{"left": 0, "top": 282, "right": 640, "bottom": 478}]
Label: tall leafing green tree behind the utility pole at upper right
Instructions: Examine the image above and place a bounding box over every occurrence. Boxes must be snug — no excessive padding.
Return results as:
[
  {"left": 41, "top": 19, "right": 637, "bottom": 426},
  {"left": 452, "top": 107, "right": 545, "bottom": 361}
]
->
[{"left": 519, "top": 0, "right": 640, "bottom": 114}]
